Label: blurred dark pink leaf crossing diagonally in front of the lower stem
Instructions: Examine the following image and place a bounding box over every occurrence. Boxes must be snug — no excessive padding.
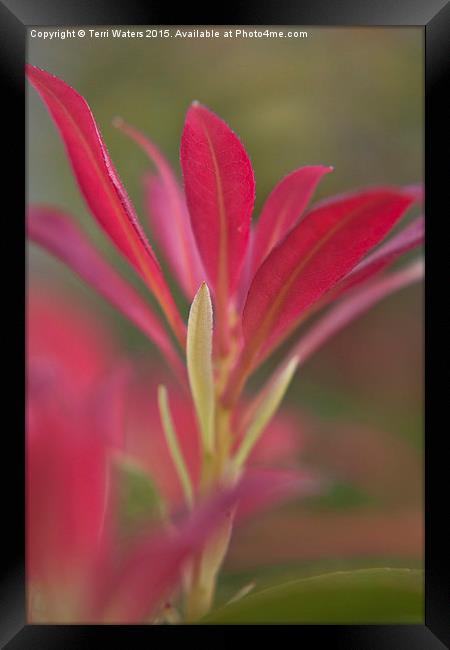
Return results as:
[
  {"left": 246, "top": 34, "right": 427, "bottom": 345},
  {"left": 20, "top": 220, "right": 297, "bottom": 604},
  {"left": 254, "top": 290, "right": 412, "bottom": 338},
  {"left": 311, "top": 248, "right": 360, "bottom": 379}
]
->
[{"left": 89, "top": 470, "right": 298, "bottom": 623}]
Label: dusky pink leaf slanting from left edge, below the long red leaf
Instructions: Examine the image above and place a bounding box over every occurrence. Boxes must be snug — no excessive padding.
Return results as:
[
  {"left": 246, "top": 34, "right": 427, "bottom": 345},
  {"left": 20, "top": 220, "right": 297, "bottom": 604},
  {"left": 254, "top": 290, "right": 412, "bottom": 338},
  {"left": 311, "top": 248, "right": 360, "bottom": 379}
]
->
[{"left": 27, "top": 205, "right": 186, "bottom": 377}]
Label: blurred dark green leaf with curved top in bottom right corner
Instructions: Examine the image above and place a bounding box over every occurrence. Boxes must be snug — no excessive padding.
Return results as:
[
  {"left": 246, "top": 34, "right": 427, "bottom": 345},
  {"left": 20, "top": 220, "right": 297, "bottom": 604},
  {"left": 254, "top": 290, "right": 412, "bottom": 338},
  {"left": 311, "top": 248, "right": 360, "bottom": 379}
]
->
[{"left": 202, "top": 568, "right": 424, "bottom": 625}]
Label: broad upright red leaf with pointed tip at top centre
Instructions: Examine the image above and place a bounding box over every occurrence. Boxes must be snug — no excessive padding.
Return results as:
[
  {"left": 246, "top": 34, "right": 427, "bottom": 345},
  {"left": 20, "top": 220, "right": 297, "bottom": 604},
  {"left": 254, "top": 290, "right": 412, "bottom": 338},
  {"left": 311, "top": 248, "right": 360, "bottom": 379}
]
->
[{"left": 181, "top": 103, "right": 255, "bottom": 303}]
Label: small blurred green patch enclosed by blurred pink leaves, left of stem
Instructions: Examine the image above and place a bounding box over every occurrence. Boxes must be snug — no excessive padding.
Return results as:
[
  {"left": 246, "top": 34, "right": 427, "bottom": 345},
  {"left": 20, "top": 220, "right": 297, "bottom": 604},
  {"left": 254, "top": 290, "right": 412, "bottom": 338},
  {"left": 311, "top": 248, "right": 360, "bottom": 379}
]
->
[{"left": 116, "top": 456, "right": 166, "bottom": 536}]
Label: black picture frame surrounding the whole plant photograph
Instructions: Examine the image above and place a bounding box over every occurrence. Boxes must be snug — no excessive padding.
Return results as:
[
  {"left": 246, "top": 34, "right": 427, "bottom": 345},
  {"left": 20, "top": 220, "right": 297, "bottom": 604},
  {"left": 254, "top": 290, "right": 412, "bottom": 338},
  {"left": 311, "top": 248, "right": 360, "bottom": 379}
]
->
[{"left": 0, "top": 0, "right": 450, "bottom": 650}]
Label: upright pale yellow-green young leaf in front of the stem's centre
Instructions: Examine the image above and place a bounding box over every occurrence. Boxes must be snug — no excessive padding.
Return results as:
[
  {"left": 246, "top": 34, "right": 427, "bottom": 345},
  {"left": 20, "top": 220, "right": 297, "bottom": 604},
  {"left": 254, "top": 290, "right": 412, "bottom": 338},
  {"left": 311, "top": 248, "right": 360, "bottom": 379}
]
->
[{"left": 186, "top": 283, "right": 215, "bottom": 452}]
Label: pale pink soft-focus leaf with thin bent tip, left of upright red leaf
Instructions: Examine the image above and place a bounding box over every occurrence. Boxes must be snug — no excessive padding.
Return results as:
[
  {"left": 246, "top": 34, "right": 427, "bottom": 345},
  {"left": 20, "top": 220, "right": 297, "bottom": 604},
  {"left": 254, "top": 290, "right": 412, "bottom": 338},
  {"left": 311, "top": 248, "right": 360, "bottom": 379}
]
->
[{"left": 114, "top": 118, "right": 205, "bottom": 300}]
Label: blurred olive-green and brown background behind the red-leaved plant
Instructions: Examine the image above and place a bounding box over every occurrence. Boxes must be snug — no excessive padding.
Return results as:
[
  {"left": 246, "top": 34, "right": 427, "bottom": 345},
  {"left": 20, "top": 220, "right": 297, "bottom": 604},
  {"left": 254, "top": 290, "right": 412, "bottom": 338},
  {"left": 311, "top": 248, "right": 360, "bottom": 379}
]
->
[{"left": 27, "top": 28, "right": 423, "bottom": 598}]
